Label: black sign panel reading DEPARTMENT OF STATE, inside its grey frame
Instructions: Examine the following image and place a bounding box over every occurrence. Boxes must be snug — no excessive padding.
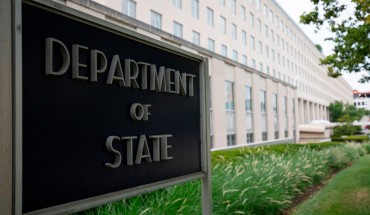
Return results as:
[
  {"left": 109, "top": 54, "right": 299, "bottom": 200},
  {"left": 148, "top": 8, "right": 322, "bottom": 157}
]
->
[{"left": 22, "top": 3, "right": 201, "bottom": 213}]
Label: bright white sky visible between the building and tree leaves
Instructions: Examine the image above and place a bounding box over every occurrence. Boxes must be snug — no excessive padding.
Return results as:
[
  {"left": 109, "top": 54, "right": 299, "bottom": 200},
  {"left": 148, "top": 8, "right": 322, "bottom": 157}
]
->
[{"left": 275, "top": 0, "right": 370, "bottom": 92}]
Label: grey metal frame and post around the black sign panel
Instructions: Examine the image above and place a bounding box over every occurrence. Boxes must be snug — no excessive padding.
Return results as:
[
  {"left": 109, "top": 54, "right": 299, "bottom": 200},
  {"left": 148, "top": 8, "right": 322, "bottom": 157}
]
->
[{"left": 12, "top": 0, "right": 212, "bottom": 215}]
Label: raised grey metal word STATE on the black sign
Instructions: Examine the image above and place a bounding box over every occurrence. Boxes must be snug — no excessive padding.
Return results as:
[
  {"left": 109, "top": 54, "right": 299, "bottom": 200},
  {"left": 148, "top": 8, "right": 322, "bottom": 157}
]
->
[{"left": 105, "top": 134, "right": 173, "bottom": 168}]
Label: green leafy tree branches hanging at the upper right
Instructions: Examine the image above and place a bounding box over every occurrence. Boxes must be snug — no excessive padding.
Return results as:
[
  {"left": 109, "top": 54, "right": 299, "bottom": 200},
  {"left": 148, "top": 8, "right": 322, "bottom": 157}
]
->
[{"left": 300, "top": 0, "right": 370, "bottom": 83}]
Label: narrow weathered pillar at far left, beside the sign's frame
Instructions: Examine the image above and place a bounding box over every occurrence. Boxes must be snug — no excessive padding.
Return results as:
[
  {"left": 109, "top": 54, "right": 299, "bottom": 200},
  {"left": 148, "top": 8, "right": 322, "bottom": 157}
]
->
[{"left": 0, "top": 1, "right": 13, "bottom": 215}]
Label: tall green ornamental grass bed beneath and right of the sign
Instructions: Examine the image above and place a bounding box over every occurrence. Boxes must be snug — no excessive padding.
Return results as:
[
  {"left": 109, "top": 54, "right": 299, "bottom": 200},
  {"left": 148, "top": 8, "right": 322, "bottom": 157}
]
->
[{"left": 79, "top": 143, "right": 370, "bottom": 215}]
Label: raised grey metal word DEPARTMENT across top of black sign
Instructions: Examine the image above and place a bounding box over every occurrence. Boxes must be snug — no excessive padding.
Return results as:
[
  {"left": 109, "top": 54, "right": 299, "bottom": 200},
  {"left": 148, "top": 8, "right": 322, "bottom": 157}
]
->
[{"left": 45, "top": 38, "right": 196, "bottom": 96}]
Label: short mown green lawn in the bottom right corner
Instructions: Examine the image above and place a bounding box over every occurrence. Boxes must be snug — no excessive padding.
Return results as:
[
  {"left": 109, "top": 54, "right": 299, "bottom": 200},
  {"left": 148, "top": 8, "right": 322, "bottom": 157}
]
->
[{"left": 292, "top": 155, "right": 370, "bottom": 215}]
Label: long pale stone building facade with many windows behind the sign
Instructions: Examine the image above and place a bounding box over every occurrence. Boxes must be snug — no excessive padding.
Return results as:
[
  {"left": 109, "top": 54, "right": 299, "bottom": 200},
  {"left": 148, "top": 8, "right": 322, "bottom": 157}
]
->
[{"left": 59, "top": 0, "right": 352, "bottom": 148}]
